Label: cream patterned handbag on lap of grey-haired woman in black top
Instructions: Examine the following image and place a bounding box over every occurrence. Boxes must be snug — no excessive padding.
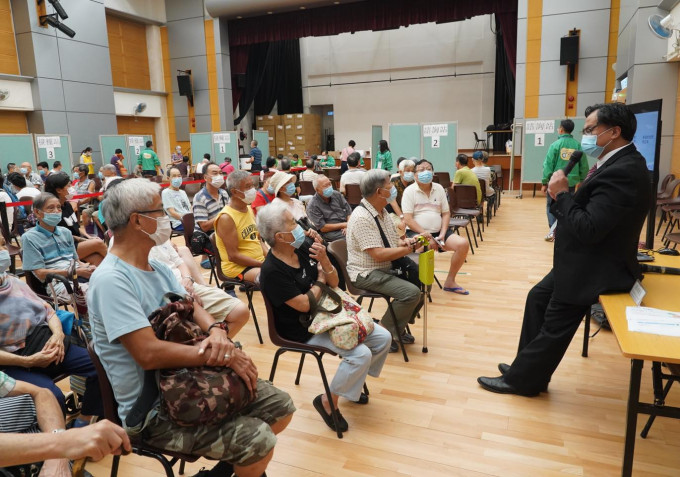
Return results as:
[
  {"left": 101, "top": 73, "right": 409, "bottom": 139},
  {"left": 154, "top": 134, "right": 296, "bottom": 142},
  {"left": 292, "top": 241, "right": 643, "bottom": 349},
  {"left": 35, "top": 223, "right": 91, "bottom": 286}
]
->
[{"left": 308, "top": 282, "right": 374, "bottom": 350}]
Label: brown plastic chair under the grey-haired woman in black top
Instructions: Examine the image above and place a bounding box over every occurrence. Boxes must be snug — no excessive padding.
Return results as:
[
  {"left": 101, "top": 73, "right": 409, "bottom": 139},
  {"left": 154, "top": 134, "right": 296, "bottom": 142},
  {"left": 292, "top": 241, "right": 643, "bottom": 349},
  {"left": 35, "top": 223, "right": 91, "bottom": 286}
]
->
[{"left": 262, "top": 293, "right": 354, "bottom": 439}]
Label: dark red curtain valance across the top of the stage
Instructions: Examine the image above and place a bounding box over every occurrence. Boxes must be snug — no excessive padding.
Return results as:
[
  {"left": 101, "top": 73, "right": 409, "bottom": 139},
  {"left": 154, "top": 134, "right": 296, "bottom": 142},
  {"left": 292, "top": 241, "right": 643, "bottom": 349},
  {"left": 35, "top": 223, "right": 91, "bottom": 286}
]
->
[{"left": 229, "top": 0, "right": 517, "bottom": 48}]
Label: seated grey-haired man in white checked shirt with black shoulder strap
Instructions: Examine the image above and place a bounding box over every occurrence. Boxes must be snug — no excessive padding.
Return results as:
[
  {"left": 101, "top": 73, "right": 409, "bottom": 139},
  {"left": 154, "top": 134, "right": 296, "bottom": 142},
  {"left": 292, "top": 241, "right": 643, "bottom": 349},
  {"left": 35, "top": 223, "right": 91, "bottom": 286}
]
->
[{"left": 347, "top": 169, "right": 423, "bottom": 352}]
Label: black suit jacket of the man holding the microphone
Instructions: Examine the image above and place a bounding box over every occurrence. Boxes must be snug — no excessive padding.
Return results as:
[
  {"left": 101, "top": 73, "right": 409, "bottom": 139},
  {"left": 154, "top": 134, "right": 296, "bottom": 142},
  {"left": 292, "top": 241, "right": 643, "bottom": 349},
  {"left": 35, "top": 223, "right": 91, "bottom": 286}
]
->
[{"left": 550, "top": 144, "right": 652, "bottom": 305}]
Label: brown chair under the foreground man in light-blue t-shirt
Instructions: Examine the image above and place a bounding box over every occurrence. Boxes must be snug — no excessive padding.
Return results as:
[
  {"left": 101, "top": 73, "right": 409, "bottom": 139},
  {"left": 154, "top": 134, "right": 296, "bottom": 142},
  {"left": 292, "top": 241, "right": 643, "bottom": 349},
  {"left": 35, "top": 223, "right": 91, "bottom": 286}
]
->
[{"left": 87, "top": 342, "right": 198, "bottom": 477}]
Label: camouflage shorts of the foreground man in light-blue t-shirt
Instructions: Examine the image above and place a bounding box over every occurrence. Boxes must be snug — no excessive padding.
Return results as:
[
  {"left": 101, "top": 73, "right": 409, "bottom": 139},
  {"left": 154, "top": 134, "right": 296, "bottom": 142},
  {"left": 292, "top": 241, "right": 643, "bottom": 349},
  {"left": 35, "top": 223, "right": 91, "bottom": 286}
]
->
[{"left": 142, "top": 379, "right": 295, "bottom": 466}]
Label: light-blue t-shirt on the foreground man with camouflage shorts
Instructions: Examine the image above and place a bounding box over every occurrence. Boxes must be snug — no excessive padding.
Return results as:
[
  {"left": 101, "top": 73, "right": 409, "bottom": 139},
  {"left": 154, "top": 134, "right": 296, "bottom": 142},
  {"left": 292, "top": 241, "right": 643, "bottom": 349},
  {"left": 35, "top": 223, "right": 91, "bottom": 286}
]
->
[{"left": 87, "top": 252, "right": 186, "bottom": 422}]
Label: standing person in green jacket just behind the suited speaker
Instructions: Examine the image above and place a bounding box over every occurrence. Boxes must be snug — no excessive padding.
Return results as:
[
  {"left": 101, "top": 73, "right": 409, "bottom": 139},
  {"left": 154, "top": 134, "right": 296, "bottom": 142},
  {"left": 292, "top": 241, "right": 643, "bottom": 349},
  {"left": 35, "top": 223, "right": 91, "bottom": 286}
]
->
[{"left": 541, "top": 119, "right": 588, "bottom": 238}]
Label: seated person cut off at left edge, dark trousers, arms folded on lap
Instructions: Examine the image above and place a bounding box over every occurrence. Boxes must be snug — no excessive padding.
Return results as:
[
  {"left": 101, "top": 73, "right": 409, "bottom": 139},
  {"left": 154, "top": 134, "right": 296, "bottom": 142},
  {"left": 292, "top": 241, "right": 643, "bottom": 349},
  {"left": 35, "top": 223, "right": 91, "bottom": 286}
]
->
[{"left": 0, "top": 236, "right": 102, "bottom": 426}]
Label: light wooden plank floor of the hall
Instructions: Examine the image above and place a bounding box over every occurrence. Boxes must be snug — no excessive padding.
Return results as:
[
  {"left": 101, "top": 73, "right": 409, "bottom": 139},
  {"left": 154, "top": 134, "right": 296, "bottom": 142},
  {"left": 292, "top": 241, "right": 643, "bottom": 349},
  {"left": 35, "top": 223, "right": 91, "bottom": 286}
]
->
[{"left": 81, "top": 194, "right": 680, "bottom": 477}]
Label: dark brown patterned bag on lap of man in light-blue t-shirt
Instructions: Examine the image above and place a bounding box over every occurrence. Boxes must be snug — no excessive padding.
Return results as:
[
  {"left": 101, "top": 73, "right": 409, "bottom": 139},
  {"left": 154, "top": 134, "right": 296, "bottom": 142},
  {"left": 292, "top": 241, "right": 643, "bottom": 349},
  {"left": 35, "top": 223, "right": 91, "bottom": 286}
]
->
[{"left": 133, "top": 293, "right": 254, "bottom": 427}]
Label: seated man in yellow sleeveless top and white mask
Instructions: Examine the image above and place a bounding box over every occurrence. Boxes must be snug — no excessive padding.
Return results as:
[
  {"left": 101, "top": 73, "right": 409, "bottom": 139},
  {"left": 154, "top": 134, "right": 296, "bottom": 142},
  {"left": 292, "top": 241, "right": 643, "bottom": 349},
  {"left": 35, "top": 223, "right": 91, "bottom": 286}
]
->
[{"left": 215, "top": 171, "right": 264, "bottom": 282}]
